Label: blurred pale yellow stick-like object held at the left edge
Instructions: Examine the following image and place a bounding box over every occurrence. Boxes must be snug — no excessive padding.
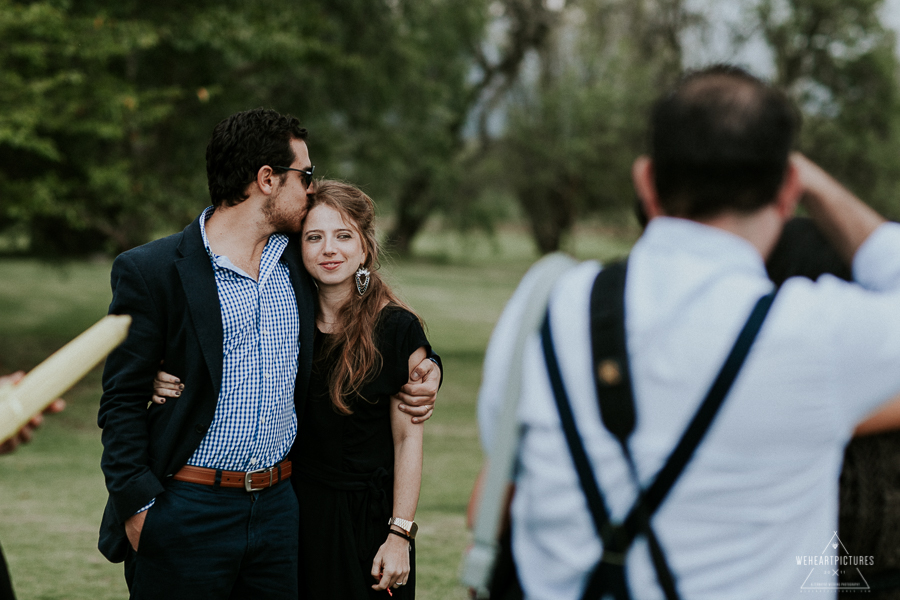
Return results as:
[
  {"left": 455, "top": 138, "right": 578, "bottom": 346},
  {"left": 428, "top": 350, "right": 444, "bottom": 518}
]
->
[{"left": 0, "top": 315, "right": 131, "bottom": 443}]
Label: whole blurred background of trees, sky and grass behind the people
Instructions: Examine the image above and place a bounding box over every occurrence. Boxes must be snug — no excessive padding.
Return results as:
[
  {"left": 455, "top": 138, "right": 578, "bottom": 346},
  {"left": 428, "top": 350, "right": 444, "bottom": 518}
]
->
[{"left": 0, "top": 0, "right": 900, "bottom": 600}]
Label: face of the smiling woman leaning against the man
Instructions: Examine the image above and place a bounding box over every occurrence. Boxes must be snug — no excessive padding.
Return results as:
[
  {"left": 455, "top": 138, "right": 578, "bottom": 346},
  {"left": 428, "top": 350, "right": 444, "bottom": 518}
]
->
[{"left": 302, "top": 204, "right": 366, "bottom": 289}]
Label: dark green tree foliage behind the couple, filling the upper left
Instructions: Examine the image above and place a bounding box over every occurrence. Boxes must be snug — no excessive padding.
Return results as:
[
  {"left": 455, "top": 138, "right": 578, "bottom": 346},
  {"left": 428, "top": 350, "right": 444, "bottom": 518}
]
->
[{"left": 0, "top": 0, "right": 486, "bottom": 254}]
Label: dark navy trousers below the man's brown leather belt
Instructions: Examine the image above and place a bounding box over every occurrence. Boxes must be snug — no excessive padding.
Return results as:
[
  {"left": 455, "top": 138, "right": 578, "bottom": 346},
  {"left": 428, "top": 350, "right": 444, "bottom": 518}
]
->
[{"left": 125, "top": 481, "right": 299, "bottom": 600}]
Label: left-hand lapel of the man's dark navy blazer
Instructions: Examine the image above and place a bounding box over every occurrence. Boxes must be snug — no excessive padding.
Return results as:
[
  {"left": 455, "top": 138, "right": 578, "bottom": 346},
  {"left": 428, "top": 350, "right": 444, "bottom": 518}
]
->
[{"left": 175, "top": 218, "right": 225, "bottom": 394}]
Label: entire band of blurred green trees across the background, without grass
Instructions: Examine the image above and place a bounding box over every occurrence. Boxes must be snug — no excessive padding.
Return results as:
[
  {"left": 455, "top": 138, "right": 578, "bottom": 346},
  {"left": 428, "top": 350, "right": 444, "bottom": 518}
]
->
[{"left": 0, "top": 0, "right": 900, "bottom": 256}]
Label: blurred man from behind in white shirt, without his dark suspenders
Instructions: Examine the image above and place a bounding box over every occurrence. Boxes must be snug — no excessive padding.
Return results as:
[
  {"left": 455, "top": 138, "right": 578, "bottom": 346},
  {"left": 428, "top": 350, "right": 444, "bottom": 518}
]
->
[{"left": 479, "top": 66, "right": 900, "bottom": 600}]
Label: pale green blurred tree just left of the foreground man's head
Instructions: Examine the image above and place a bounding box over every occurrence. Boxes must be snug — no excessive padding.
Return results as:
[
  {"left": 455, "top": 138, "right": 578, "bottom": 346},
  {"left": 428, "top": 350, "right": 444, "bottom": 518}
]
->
[{"left": 500, "top": 0, "right": 699, "bottom": 253}]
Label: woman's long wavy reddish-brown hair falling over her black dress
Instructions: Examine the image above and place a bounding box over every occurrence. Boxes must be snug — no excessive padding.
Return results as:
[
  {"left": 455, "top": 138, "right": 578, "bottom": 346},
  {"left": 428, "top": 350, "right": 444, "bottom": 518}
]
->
[{"left": 309, "top": 179, "right": 420, "bottom": 415}]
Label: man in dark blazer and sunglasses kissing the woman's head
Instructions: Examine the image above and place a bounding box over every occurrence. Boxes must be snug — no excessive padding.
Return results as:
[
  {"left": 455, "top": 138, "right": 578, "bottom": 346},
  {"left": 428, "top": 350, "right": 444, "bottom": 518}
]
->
[{"left": 98, "top": 109, "right": 440, "bottom": 600}]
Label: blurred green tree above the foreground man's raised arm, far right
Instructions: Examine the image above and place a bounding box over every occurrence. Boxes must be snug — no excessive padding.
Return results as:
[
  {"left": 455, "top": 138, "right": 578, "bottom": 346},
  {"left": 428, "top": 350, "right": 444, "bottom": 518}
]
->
[{"left": 757, "top": 0, "right": 900, "bottom": 218}]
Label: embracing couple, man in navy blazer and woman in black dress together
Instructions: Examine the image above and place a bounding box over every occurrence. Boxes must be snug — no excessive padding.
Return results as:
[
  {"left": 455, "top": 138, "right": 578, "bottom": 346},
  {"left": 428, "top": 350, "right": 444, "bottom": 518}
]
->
[{"left": 98, "top": 109, "right": 441, "bottom": 600}]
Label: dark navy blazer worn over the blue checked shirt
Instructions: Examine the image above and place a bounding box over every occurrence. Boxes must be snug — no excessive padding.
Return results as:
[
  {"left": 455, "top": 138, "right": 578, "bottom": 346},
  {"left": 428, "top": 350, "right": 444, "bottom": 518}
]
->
[{"left": 98, "top": 218, "right": 315, "bottom": 562}]
